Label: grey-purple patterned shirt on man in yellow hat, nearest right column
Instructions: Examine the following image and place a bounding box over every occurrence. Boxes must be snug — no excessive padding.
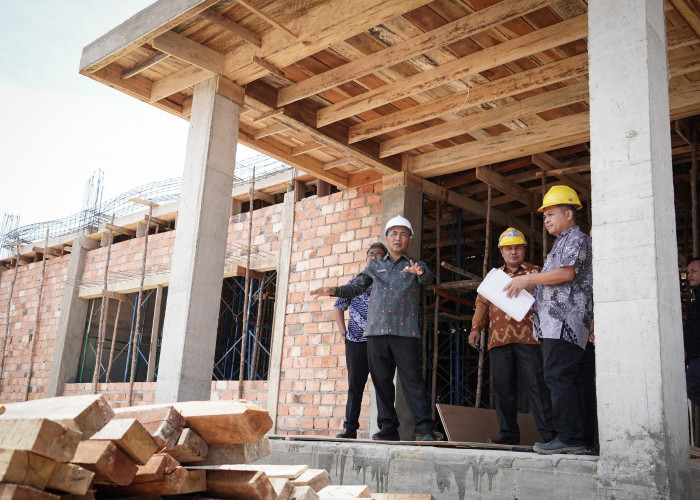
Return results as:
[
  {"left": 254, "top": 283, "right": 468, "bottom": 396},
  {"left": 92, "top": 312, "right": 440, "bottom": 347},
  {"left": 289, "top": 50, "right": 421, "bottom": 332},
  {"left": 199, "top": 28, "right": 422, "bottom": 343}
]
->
[{"left": 533, "top": 226, "right": 593, "bottom": 349}]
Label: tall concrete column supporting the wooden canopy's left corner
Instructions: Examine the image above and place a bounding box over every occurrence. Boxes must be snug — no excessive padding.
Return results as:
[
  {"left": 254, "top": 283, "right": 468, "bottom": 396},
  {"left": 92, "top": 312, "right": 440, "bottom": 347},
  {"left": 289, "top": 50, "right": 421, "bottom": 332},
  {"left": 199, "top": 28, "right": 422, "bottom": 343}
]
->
[{"left": 155, "top": 77, "right": 240, "bottom": 403}]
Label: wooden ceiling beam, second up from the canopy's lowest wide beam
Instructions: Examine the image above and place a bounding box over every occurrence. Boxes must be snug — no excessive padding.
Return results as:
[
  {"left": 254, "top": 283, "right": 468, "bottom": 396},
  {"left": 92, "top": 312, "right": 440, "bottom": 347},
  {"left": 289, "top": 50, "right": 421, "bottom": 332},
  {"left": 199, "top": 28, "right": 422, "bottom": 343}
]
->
[{"left": 379, "top": 82, "right": 588, "bottom": 158}]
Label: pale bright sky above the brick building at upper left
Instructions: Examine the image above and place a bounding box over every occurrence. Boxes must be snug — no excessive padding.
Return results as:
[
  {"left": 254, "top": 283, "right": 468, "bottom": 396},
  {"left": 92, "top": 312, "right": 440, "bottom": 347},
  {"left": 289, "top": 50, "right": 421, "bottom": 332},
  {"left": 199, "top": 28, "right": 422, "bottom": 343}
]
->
[{"left": 0, "top": 0, "right": 254, "bottom": 226}]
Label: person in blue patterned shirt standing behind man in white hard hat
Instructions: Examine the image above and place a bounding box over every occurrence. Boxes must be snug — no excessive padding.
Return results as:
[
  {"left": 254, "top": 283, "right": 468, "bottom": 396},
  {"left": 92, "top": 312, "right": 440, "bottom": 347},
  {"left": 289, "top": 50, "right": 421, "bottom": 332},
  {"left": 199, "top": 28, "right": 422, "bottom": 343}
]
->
[{"left": 333, "top": 243, "right": 387, "bottom": 439}]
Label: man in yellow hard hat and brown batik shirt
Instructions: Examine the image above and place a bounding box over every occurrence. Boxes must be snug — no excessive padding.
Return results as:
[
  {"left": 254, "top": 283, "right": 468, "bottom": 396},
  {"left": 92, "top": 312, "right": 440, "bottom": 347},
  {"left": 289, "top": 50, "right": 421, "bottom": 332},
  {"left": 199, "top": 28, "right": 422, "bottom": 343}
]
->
[{"left": 469, "top": 227, "right": 554, "bottom": 444}]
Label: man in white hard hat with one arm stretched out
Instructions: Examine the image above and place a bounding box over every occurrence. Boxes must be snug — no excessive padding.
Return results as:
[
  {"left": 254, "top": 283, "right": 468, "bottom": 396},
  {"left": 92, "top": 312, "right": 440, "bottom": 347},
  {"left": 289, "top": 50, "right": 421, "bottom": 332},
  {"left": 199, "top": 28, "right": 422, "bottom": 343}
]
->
[{"left": 311, "top": 215, "right": 436, "bottom": 441}]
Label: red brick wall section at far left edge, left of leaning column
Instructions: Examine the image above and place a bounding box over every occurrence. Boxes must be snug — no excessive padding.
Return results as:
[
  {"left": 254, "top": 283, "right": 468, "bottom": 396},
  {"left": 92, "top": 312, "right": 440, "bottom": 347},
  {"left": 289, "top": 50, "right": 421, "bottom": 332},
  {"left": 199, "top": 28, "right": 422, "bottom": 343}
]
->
[{"left": 0, "top": 255, "right": 70, "bottom": 402}]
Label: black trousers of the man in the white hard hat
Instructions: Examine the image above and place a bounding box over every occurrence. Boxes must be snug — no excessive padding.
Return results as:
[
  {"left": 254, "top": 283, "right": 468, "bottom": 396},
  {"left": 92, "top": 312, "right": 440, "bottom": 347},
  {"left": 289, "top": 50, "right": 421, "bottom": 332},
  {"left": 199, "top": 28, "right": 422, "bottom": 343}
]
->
[{"left": 367, "top": 335, "right": 434, "bottom": 433}]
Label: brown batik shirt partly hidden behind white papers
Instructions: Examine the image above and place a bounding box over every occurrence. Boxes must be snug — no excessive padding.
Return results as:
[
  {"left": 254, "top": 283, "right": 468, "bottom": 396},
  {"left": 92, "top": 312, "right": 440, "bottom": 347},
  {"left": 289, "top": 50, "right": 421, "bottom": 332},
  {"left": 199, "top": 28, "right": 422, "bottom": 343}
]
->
[{"left": 471, "top": 262, "right": 540, "bottom": 349}]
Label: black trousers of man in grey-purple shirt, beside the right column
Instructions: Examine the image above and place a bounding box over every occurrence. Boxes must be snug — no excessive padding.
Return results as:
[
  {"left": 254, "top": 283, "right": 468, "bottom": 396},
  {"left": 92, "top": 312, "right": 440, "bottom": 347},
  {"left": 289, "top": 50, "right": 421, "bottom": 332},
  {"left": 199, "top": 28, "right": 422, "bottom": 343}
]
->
[{"left": 541, "top": 339, "right": 584, "bottom": 445}]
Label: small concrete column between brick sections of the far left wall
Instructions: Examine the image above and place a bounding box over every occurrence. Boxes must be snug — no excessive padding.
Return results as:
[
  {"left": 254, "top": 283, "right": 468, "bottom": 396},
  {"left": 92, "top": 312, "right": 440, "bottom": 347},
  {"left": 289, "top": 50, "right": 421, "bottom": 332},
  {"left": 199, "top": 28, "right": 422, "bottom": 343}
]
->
[{"left": 46, "top": 236, "right": 100, "bottom": 398}]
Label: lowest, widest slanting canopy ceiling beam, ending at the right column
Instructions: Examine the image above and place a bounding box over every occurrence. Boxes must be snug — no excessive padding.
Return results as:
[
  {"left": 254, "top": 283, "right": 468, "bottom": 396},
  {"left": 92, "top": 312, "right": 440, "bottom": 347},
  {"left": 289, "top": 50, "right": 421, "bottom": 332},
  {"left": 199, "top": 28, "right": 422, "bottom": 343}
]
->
[{"left": 412, "top": 112, "right": 590, "bottom": 177}]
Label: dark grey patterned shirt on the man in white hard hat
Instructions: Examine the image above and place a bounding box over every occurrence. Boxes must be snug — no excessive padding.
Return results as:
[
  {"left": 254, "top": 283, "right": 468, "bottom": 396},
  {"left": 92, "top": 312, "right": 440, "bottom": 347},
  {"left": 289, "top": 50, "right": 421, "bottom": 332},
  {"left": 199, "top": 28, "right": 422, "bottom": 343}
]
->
[{"left": 333, "top": 254, "right": 434, "bottom": 338}]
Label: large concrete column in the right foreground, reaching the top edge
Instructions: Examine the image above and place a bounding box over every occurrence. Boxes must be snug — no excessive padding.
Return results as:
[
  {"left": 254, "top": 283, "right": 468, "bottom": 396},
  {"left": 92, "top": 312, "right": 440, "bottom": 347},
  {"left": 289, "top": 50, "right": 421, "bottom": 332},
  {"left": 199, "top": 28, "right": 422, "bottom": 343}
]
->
[{"left": 588, "top": 0, "right": 690, "bottom": 498}]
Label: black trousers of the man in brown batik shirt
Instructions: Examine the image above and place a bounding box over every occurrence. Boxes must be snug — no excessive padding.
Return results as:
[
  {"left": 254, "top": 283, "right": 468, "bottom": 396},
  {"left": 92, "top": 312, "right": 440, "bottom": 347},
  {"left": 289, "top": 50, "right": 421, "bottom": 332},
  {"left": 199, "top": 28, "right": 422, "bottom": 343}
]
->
[{"left": 489, "top": 344, "right": 554, "bottom": 442}]
